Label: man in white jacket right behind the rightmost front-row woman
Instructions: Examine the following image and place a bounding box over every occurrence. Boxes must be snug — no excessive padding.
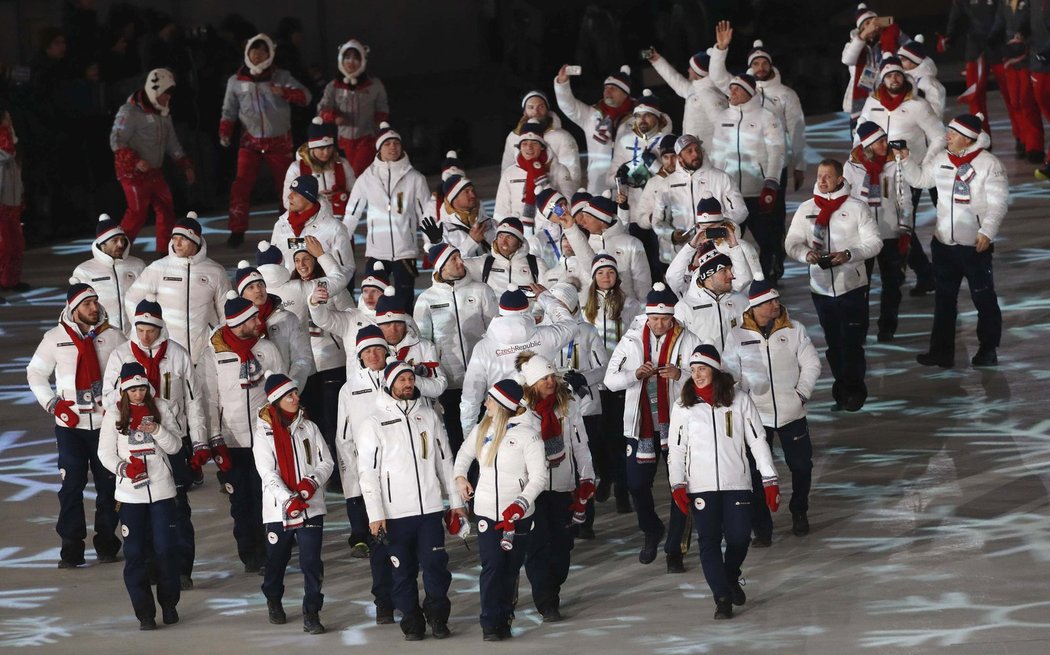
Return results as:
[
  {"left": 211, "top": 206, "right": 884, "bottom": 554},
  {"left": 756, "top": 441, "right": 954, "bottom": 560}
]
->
[{"left": 727, "top": 280, "right": 820, "bottom": 547}]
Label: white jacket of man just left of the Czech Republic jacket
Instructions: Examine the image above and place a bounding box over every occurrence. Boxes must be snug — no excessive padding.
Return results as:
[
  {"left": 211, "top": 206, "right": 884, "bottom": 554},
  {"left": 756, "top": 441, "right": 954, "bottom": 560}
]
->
[{"left": 413, "top": 274, "right": 500, "bottom": 389}]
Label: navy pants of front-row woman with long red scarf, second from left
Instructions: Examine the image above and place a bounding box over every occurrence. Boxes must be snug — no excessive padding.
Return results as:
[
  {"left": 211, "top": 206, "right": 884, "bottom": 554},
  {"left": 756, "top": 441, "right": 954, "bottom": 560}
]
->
[{"left": 263, "top": 516, "right": 324, "bottom": 614}]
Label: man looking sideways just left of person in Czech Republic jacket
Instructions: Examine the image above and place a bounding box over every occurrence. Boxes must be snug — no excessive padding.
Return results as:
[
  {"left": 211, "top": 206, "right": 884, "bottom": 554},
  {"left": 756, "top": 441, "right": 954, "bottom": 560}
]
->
[{"left": 413, "top": 244, "right": 499, "bottom": 452}]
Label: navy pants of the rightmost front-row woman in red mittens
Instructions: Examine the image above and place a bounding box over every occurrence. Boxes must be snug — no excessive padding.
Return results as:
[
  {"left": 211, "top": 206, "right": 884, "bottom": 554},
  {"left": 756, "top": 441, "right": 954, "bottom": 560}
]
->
[{"left": 689, "top": 490, "right": 752, "bottom": 598}]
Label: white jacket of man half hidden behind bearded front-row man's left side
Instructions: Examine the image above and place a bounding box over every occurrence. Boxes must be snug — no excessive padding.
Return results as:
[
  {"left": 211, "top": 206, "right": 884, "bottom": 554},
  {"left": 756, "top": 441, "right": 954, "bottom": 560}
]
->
[{"left": 335, "top": 366, "right": 384, "bottom": 499}]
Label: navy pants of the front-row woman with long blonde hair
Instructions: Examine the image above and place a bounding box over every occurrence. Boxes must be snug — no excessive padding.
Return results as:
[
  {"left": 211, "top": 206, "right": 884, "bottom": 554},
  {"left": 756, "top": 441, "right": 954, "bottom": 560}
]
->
[{"left": 478, "top": 516, "right": 532, "bottom": 630}]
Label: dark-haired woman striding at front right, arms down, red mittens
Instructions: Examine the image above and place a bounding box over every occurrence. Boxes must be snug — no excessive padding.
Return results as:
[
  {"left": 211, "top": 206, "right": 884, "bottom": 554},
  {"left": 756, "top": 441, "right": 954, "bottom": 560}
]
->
[{"left": 667, "top": 344, "right": 780, "bottom": 619}]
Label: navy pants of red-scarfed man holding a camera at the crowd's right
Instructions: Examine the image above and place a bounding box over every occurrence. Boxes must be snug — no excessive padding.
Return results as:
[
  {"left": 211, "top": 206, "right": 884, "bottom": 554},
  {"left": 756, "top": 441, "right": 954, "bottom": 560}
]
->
[{"left": 812, "top": 287, "right": 867, "bottom": 403}]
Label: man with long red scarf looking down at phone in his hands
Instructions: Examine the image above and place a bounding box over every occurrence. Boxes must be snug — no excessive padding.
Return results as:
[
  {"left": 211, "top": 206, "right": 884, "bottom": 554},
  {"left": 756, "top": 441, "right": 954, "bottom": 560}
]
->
[{"left": 605, "top": 282, "right": 699, "bottom": 570}]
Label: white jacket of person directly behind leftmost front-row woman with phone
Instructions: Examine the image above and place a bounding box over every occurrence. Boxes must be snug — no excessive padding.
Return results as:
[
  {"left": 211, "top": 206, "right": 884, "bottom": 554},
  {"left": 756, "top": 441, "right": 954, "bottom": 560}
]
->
[{"left": 102, "top": 331, "right": 211, "bottom": 445}]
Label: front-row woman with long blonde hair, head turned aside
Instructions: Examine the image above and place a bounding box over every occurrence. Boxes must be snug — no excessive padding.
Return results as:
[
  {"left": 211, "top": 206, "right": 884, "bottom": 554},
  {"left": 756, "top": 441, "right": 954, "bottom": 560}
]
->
[{"left": 453, "top": 380, "right": 547, "bottom": 641}]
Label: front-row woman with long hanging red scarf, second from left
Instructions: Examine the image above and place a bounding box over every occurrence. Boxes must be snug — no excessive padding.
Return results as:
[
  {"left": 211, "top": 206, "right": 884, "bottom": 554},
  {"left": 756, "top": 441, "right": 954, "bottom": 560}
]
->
[{"left": 252, "top": 372, "right": 335, "bottom": 634}]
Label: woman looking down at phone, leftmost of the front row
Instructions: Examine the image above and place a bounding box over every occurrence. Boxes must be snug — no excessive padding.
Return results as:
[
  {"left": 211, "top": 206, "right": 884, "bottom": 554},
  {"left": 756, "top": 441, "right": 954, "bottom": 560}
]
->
[{"left": 99, "top": 362, "right": 183, "bottom": 630}]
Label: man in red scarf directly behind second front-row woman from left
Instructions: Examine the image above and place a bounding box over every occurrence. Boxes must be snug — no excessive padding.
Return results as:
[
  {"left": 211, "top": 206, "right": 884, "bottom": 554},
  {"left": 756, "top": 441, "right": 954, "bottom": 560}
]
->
[{"left": 201, "top": 291, "right": 287, "bottom": 573}]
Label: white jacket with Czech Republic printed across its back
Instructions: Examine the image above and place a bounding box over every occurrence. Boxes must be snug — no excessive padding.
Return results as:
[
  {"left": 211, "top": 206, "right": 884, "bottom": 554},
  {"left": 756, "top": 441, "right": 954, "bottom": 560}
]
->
[{"left": 460, "top": 291, "right": 576, "bottom": 435}]
